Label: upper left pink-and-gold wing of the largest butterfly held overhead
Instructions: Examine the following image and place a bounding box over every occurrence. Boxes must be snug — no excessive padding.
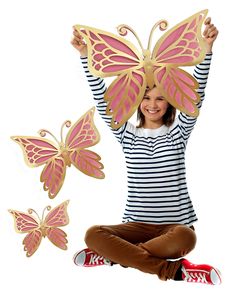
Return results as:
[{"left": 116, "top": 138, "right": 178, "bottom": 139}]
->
[{"left": 75, "top": 25, "right": 143, "bottom": 77}]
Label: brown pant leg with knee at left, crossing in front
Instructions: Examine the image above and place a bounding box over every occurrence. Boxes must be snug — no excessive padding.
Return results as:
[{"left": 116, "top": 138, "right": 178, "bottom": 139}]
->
[{"left": 85, "top": 222, "right": 186, "bottom": 280}]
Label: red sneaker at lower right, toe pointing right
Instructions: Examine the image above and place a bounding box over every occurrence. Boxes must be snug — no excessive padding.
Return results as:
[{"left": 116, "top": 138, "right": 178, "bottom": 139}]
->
[{"left": 182, "top": 259, "right": 221, "bottom": 285}]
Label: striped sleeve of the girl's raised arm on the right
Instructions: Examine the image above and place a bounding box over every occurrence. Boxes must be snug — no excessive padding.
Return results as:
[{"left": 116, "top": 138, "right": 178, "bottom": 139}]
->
[{"left": 178, "top": 54, "right": 212, "bottom": 144}]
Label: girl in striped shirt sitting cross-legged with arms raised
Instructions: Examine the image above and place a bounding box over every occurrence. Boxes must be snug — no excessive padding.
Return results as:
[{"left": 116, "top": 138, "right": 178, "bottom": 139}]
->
[{"left": 72, "top": 18, "right": 221, "bottom": 285}]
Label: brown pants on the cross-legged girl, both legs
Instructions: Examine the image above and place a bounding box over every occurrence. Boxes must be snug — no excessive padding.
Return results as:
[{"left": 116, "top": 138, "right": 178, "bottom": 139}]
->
[{"left": 85, "top": 222, "right": 196, "bottom": 280}]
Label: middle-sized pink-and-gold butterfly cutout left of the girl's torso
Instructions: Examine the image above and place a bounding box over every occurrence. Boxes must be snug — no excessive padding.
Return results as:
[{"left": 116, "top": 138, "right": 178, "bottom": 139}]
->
[{"left": 12, "top": 107, "right": 104, "bottom": 198}]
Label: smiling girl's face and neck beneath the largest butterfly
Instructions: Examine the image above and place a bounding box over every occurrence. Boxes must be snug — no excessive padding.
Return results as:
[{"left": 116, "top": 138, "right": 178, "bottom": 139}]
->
[{"left": 140, "top": 87, "right": 169, "bottom": 128}]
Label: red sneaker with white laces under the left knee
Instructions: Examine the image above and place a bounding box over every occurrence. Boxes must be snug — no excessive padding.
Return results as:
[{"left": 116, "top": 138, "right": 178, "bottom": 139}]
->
[{"left": 73, "top": 249, "right": 112, "bottom": 267}]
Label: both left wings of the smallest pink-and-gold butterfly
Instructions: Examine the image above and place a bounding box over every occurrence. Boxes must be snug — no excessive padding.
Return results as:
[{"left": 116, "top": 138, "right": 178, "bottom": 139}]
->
[{"left": 9, "top": 210, "right": 42, "bottom": 257}]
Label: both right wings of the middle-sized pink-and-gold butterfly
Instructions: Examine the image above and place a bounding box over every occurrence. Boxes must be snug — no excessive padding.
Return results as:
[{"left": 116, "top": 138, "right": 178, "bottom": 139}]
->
[{"left": 65, "top": 107, "right": 104, "bottom": 179}]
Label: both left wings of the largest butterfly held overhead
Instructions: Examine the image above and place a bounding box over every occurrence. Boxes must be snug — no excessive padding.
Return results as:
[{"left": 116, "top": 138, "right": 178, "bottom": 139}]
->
[{"left": 76, "top": 25, "right": 146, "bottom": 129}]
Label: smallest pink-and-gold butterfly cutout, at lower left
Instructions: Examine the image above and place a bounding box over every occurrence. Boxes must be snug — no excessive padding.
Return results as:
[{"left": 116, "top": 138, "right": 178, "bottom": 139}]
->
[{"left": 9, "top": 200, "right": 69, "bottom": 257}]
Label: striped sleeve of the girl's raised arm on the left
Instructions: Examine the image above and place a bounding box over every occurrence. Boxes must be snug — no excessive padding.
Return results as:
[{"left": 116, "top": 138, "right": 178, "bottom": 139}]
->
[{"left": 81, "top": 57, "right": 128, "bottom": 143}]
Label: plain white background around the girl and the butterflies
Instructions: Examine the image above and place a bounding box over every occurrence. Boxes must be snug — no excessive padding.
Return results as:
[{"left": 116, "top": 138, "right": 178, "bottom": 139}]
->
[{"left": 0, "top": 0, "right": 236, "bottom": 291}]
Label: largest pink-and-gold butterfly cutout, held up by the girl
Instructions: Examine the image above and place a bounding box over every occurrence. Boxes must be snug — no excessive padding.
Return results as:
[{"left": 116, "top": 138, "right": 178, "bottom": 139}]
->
[{"left": 75, "top": 10, "right": 208, "bottom": 129}]
